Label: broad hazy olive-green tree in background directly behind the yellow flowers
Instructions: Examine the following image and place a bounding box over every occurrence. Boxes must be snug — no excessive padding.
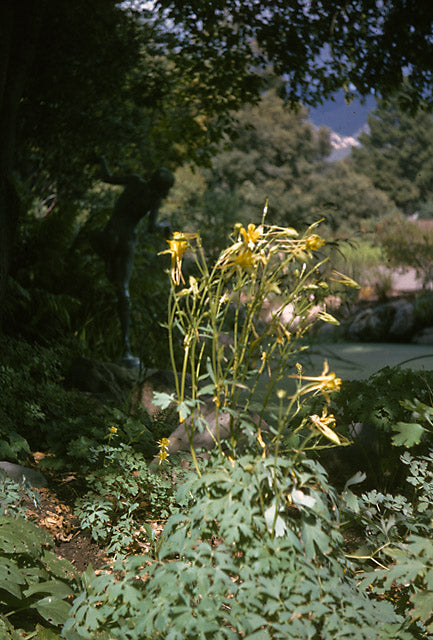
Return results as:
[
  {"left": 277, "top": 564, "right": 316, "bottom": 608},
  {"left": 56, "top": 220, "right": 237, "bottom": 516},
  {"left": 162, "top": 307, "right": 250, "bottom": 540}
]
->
[{"left": 166, "top": 90, "right": 396, "bottom": 241}]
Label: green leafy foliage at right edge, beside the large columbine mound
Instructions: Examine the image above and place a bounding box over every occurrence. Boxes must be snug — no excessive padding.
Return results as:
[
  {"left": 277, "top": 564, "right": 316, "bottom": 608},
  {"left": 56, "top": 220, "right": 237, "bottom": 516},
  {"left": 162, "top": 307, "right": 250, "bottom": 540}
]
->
[{"left": 343, "top": 451, "right": 433, "bottom": 638}]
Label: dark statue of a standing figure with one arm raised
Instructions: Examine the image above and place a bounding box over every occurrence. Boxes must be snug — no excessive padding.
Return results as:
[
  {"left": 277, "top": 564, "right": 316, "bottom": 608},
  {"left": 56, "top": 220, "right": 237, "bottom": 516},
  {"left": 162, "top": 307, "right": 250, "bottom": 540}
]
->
[{"left": 92, "top": 157, "right": 174, "bottom": 367}]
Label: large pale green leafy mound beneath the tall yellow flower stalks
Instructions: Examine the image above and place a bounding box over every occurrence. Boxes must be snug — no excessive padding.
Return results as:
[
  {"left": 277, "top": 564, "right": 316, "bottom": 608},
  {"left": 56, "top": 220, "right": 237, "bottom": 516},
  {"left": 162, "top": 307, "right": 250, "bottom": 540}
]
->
[{"left": 64, "top": 453, "right": 408, "bottom": 640}]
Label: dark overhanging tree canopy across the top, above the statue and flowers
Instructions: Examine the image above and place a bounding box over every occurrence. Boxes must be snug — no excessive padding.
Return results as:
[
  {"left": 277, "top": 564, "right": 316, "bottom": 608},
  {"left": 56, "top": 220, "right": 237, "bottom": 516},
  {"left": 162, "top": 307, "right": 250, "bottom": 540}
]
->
[{"left": 0, "top": 0, "right": 433, "bottom": 320}]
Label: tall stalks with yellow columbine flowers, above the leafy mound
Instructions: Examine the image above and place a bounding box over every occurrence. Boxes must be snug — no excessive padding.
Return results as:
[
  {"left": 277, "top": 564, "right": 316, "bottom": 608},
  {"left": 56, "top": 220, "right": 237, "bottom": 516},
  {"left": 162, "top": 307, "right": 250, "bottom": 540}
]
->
[{"left": 156, "top": 209, "right": 355, "bottom": 473}]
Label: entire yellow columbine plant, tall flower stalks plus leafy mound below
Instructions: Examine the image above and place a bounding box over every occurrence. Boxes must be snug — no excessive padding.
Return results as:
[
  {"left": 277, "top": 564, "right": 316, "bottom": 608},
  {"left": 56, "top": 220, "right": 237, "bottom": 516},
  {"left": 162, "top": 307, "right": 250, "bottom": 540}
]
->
[{"left": 64, "top": 218, "right": 398, "bottom": 640}]
